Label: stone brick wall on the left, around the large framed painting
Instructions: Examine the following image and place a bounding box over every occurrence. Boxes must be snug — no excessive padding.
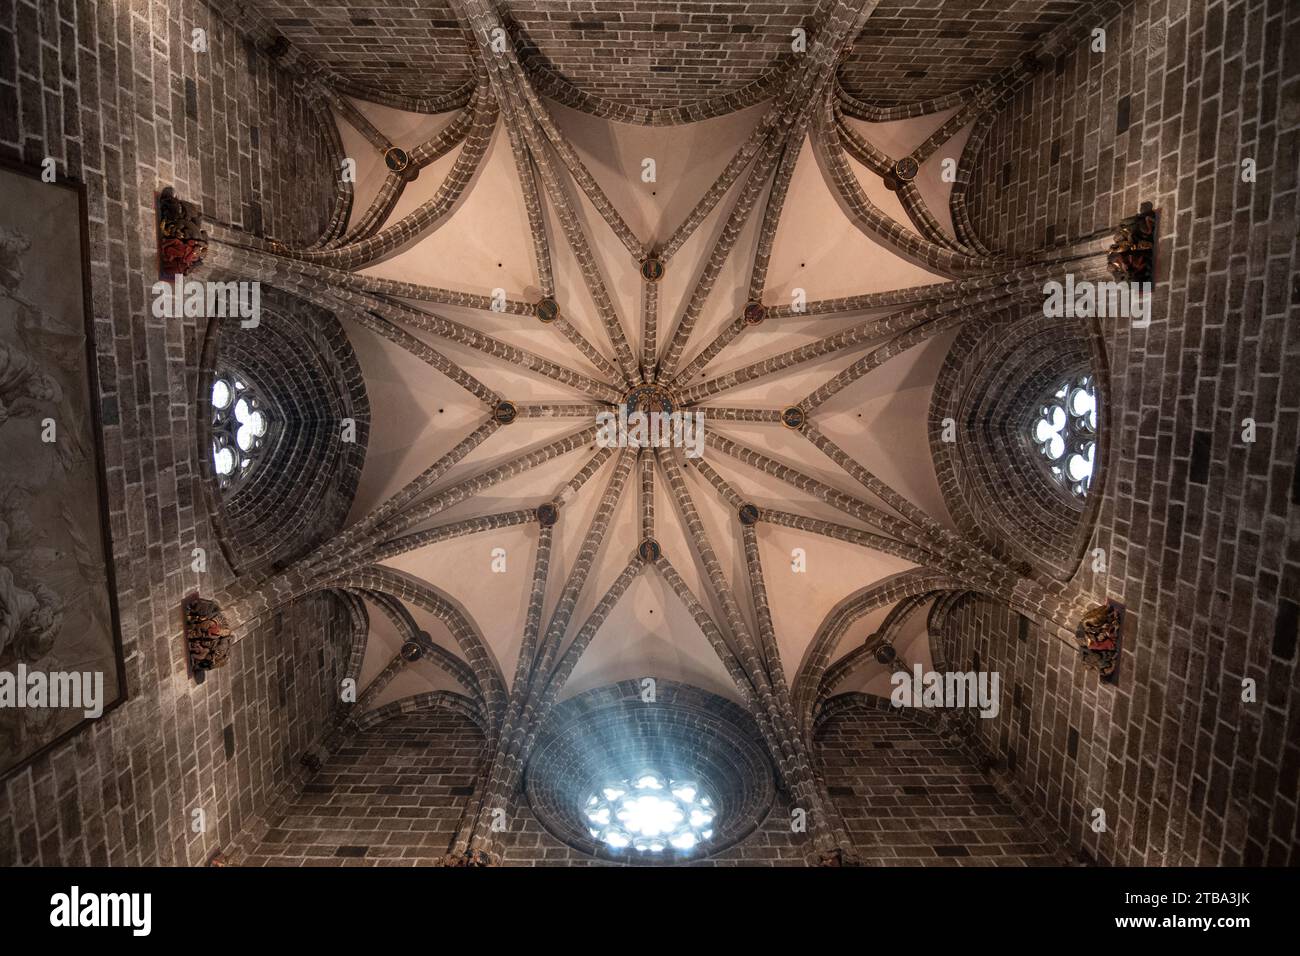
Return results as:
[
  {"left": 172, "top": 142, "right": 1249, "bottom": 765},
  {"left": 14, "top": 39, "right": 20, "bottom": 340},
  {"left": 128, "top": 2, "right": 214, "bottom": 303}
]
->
[{"left": 0, "top": 0, "right": 346, "bottom": 865}]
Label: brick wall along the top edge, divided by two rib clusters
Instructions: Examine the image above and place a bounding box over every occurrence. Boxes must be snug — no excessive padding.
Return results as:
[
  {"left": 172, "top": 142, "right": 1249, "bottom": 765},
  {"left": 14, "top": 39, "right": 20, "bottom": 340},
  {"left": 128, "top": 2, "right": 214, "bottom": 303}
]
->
[{"left": 239, "top": 0, "right": 1088, "bottom": 122}]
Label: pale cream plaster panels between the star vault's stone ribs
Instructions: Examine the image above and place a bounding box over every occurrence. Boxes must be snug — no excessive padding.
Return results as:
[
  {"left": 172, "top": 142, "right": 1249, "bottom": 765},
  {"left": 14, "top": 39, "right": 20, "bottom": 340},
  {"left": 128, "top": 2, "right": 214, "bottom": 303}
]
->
[{"left": 342, "top": 95, "right": 952, "bottom": 702}]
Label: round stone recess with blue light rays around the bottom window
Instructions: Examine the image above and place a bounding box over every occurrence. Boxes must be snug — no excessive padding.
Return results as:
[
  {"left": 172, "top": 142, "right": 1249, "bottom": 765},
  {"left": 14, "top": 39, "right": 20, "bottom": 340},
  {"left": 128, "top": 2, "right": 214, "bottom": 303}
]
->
[{"left": 524, "top": 679, "right": 776, "bottom": 864}]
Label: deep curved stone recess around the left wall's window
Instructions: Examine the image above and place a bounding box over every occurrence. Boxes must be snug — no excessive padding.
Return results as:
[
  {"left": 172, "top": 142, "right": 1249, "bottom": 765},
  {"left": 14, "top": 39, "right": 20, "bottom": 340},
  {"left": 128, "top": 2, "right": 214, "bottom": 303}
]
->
[{"left": 195, "top": 285, "right": 371, "bottom": 576}]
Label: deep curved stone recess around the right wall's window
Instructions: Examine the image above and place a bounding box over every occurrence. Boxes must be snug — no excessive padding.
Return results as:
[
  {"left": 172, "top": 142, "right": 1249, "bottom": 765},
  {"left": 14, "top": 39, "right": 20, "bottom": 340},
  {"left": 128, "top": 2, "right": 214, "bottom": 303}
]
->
[{"left": 928, "top": 310, "right": 1109, "bottom": 581}]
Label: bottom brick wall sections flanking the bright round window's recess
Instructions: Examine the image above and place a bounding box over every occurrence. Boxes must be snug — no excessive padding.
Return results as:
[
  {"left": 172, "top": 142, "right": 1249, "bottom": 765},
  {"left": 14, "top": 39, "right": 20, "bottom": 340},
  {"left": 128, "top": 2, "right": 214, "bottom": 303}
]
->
[{"left": 239, "top": 708, "right": 1053, "bottom": 866}]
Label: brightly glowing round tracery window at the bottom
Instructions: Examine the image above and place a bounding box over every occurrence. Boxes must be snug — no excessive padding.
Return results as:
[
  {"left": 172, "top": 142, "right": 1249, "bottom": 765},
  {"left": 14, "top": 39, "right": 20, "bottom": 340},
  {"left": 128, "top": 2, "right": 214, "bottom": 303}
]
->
[{"left": 584, "top": 771, "right": 716, "bottom": 853}]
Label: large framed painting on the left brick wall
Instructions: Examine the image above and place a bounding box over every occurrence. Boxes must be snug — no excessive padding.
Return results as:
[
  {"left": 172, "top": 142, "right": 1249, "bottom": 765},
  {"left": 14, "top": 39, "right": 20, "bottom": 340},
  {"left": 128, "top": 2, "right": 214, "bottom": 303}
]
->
[{"left": 0, "top": 163, "right": 126, "bottom": 779}]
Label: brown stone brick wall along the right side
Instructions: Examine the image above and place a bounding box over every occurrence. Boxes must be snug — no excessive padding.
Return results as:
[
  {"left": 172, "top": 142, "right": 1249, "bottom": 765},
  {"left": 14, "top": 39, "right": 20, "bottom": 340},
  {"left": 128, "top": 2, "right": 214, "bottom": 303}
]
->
[{"left": 959, "top": 0, "right": 1300, "bottom": 865}]
